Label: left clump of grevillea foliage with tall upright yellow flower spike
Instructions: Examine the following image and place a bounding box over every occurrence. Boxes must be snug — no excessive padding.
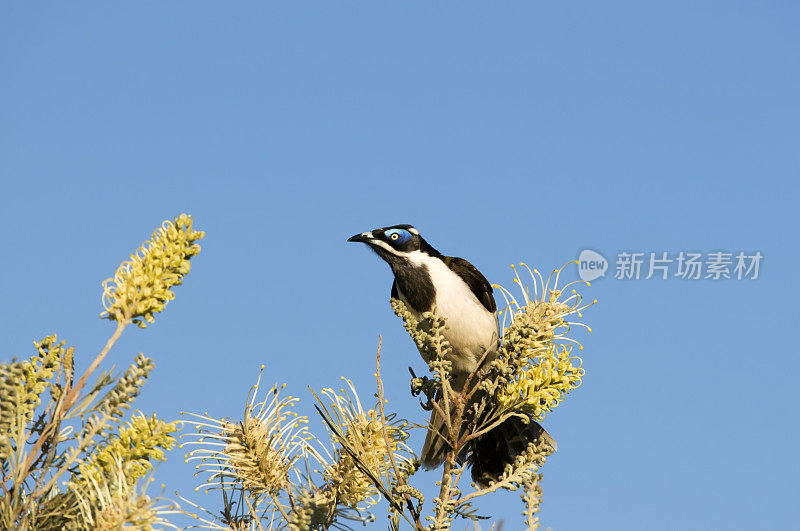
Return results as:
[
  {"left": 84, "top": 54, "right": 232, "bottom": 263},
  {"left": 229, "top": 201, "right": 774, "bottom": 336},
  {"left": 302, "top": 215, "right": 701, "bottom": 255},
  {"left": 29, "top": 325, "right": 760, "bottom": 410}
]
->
[{"left": 0, "top": 214, "right": 204, "bottom": 530}]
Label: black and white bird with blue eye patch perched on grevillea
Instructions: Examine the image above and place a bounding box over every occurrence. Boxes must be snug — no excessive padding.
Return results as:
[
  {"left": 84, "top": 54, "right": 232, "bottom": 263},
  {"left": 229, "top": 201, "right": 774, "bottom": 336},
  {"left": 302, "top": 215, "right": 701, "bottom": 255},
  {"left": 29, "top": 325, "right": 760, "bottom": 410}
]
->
[{"left": 347, "top": 224, "right": 555, "bottom": 486}]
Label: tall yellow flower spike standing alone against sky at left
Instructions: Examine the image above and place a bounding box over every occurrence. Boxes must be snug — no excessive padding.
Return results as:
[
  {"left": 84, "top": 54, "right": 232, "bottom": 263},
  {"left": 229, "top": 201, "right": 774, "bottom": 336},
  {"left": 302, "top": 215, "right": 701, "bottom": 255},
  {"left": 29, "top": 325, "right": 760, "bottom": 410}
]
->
[{"left": 100, "top": 214, "right": 205, "bottom": 328}]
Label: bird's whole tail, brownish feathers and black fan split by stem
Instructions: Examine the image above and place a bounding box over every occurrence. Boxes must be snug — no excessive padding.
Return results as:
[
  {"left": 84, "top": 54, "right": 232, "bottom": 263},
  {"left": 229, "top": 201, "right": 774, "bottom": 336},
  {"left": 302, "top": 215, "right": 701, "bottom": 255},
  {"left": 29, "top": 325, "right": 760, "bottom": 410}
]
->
[{"left": 421, "top": 409, "right": 556, "bottom": 486}]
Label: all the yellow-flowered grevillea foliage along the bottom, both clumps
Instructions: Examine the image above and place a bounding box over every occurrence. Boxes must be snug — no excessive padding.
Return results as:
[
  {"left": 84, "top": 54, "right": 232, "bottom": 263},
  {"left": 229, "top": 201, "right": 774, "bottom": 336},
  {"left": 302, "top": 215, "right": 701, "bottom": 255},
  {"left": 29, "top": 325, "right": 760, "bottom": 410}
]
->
[{"left": 0, "top": 215, "right": 593, "bottom": 531}]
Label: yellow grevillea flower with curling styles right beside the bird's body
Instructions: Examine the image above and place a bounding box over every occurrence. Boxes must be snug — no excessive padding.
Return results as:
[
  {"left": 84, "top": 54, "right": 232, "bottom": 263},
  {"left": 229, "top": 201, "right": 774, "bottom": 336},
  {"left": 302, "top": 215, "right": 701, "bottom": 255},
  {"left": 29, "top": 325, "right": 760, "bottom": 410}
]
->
[{"left": 495, "top": 262, "right": 597, "bottom": 420}]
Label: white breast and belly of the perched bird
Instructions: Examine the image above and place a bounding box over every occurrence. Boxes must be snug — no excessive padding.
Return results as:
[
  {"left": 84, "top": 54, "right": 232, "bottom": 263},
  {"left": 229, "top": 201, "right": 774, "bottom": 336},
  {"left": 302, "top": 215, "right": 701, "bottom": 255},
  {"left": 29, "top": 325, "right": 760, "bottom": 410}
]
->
[{"left": 400, "top": 251, "right": 499, "bottom": 380}]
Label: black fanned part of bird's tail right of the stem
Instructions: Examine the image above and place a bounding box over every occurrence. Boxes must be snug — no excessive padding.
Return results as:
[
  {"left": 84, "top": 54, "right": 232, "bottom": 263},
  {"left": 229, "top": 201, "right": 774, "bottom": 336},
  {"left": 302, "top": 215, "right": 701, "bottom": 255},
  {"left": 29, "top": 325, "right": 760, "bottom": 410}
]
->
[{"left": 469, "top": 417, "right": 556, "bottom": 487}]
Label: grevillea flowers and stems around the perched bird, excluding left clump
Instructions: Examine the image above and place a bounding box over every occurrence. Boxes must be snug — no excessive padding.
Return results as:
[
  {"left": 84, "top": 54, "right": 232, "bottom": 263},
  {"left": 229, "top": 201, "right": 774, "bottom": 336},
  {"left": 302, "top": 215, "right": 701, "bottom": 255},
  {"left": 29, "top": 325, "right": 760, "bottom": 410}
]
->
[{"left": 184, "top": 260, "right": 587, "bottom": 531}]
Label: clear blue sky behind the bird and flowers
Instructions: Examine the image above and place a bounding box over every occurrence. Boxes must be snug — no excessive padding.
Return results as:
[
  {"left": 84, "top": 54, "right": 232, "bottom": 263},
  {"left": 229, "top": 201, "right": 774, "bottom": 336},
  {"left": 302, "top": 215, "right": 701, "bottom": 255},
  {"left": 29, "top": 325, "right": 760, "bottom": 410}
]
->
[{"left": 0, "top": 0, "right": 800, "bottom": 531}]
